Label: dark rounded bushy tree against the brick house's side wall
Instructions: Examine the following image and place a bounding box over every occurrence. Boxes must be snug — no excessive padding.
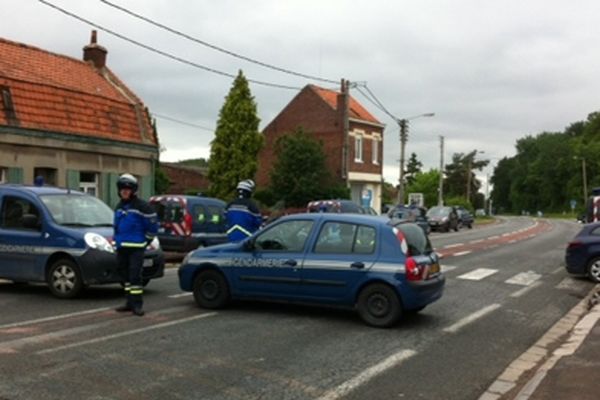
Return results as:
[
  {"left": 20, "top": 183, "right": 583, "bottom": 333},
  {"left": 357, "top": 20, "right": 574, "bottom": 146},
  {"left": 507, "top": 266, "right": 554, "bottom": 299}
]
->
[{"left": 269, "top": 128, "right": 348, "bottom": 207}]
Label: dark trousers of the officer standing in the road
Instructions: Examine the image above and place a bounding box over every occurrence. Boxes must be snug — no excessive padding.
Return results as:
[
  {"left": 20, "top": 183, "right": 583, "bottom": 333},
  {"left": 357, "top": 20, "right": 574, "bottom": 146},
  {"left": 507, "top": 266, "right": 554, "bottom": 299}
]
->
[{"left": 117, "top": 247, "right": 144, "bottom": 309}]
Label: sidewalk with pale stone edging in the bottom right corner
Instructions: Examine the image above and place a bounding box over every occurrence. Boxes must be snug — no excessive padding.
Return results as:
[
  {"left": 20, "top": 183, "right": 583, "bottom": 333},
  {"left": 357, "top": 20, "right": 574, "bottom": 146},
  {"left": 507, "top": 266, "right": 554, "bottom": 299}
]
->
[{"left": 479, "top": 285, "right": 600, "bottom": 400}]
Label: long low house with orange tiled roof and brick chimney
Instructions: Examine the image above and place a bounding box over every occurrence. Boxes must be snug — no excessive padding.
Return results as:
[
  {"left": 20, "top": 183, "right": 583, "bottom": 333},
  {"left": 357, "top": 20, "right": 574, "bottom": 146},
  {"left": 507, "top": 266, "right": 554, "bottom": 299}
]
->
[{"left": 0, "top": 31, "right": 159, "bottom": 205}]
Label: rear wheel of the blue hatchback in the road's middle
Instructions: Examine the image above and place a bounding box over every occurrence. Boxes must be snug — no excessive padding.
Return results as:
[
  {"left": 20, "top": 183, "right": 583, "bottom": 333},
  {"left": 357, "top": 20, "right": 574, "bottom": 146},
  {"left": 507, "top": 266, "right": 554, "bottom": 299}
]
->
[{"left": 356, "top": 283, "right": 402, "bottom": 328}]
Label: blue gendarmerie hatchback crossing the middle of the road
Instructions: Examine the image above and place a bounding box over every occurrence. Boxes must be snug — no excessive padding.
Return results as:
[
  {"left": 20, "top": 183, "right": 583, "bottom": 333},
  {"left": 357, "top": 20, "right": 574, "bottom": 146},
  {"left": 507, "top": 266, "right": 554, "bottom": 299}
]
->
[{"left": 178, "top": 213, "right": 445, "bottom": 327}]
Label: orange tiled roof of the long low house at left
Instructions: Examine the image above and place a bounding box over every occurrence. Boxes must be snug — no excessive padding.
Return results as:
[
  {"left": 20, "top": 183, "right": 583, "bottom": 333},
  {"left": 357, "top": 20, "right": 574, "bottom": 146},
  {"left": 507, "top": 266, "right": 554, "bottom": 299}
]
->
[{"left": 0, "top": 38, "right": 157, "bottom": 145}]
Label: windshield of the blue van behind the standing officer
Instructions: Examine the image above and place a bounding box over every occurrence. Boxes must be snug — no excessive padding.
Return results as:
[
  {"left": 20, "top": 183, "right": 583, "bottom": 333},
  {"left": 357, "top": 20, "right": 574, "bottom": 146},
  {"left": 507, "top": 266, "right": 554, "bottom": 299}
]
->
[{"left": 40, "top": 194, "right": 113, "bottom": 227}]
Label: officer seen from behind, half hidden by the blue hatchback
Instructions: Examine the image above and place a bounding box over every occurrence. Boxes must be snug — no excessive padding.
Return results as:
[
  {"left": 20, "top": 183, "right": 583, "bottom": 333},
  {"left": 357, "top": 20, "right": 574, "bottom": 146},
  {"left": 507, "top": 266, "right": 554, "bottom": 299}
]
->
[{"left": 225, "top": 179, "right": 262, "bottom": 242}]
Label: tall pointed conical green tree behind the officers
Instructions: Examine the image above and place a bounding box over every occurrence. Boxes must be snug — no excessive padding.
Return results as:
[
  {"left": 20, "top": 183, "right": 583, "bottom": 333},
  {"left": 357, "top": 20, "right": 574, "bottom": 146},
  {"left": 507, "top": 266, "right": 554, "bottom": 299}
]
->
[{"left": 208, "top": 71, "right": 263, "bottom": 199}]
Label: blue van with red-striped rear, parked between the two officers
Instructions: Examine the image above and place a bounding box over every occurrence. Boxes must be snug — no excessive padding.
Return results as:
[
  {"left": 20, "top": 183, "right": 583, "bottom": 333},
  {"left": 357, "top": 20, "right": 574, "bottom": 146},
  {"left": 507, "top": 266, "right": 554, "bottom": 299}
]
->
[{"left": 150, "top": 195, "right": 227, "bottom": 252}]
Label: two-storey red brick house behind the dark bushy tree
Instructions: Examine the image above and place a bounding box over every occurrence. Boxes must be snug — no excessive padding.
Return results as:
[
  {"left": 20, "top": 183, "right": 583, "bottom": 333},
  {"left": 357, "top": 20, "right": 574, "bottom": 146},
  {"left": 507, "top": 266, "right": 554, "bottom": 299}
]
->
[{"left": 256, "top": 82, "right": 385, "bottom": 212}]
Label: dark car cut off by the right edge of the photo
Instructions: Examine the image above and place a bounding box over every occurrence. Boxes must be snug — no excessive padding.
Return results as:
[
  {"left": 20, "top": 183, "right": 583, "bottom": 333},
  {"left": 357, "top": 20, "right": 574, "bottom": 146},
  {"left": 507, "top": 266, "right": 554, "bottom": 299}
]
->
[{"left": 565, "top": 222, "right": 600, "bottom": 283}]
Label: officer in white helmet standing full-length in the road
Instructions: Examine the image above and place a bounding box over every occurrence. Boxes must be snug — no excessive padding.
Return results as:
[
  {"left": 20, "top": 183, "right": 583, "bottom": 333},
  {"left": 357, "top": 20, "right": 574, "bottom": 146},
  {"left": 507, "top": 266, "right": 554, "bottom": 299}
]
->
[{"left": 114, "top": 174, "right": 158, "bottom": 317}]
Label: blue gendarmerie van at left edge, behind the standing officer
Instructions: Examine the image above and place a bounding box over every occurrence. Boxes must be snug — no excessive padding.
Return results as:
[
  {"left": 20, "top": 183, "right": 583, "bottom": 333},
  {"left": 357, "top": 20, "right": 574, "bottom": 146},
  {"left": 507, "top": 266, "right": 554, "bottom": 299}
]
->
[{"left": 0, "top": 184, "right": 164, "bottom": 298}]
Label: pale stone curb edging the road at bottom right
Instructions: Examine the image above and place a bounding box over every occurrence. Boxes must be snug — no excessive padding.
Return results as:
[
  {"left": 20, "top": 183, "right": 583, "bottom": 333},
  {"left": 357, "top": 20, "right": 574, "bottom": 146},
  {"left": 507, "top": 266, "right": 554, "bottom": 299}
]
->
[{"left": 479, "top": 285, "right": 600, "bottom": 400}]
